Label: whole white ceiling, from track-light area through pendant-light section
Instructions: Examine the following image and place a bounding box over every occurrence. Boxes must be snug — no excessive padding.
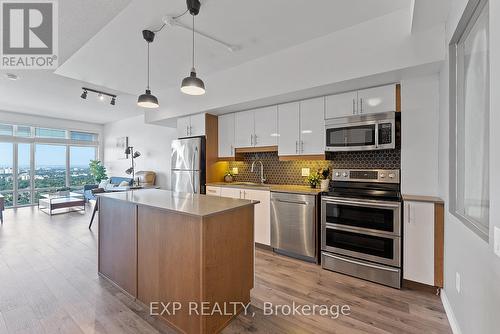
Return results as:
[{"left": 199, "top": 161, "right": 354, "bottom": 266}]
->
[{"left": 0, "top": 0, "right": 418, "bottom": 124}]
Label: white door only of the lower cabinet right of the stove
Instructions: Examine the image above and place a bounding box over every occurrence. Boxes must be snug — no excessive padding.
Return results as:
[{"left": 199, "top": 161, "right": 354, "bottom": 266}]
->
[{"left": 403, "top": 201, "right": 435, "bottom": 286}]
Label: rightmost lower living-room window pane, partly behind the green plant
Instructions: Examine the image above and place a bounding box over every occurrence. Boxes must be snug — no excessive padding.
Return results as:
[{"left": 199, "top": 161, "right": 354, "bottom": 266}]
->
[{"left": 69, "top": 146, "right": 97, "bottom": 188}]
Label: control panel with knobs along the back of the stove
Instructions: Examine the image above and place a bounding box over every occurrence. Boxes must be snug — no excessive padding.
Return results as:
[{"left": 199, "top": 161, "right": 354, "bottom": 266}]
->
[{"left": 332, "top": 169, "right": 400, "bottom": 183}]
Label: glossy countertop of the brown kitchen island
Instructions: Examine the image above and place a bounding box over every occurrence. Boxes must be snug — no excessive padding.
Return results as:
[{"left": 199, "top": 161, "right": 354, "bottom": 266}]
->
[{"left": 97, "top": 189, "right": 259, "bottom": 217}]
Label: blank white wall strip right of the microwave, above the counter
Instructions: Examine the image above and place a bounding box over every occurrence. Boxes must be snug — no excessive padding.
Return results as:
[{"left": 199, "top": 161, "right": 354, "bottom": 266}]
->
[{"left": 401, "top": 75, "right": 439, "bottom": 196}]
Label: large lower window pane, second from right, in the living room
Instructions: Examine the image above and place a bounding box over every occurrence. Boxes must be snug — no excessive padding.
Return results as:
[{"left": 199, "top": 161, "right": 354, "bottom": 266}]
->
[{"left": 35, "top": 144, "right": 66, "bottom": 189}]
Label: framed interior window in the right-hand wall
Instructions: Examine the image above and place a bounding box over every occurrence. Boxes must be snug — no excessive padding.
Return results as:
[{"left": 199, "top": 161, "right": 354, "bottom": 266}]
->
[{"left": 450, "top": 1, "right": 490, "bottom": 240}]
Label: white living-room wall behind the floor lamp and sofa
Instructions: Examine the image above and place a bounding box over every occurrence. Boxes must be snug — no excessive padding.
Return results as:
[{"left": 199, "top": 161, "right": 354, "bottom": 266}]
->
[{"left": 104, "top": 116, "right": 177, "bottom": 189}]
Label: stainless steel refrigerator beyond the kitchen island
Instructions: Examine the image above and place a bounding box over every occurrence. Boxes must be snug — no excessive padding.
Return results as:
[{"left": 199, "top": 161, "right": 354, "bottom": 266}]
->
[{"left": 170, "top": 137, "right": 205, "bottom": 194}]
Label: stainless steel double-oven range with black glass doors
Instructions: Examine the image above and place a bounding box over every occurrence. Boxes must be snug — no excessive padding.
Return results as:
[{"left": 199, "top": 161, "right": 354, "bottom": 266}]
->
[{"left": 321, "top": 170, "right": 402, "bottom": 289}]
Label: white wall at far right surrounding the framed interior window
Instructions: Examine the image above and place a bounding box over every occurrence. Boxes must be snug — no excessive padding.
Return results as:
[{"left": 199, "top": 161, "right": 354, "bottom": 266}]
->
[{"left": 439, "top": 0, "right": 500, "bottom": 334}]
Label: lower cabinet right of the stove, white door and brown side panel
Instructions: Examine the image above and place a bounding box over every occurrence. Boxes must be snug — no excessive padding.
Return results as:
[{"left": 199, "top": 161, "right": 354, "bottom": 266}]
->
[{"left": 403, "top": 201, "right": 443, "bottom": 287}]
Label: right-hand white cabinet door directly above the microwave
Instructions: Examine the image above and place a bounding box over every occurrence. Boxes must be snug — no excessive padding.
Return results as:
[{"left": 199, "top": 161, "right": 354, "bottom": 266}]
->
[{"left": 358, "top": 85, "right": 396, "bottom": 114}]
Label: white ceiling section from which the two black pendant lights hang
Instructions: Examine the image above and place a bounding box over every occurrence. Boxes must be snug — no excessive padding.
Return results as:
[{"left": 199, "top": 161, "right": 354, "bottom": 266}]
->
[{"left": 57, "top": 0, "right": 409, "bottom": 94}]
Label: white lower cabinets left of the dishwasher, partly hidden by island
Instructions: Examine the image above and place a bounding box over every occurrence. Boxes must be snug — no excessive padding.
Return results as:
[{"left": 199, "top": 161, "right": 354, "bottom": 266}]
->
[{"left": 207, "top": 186, "right": 271, "bottom": 246}]
